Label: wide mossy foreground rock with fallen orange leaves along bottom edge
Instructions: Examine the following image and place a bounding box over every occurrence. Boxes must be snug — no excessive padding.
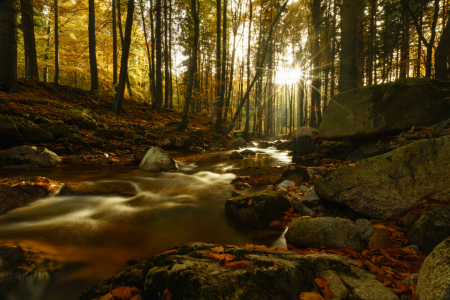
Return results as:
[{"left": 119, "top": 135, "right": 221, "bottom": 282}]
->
[{"left": 77, "top": 243, "right": 398, "bottom": 300}]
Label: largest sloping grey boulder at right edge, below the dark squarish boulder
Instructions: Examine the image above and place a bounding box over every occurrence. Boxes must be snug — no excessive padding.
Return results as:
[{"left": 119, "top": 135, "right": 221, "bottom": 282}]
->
[{"left": 315, "top": 136, "right": 450, "bottom": 218}]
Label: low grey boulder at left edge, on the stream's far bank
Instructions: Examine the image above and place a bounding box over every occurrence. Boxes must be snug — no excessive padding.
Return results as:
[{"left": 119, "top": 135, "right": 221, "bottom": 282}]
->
[{"left": 0, "top": 146, "right": 62, "bottom": 167}]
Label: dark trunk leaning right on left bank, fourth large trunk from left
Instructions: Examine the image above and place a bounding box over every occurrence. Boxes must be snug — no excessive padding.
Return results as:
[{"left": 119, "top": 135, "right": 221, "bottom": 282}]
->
[{"left": 113, "top": 0, "right": 134, "bottom": 114}]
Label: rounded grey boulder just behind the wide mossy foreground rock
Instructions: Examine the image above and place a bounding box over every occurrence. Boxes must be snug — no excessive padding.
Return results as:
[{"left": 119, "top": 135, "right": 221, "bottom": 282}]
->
[{"left": 286, "top": 217, "right": 362, "bottom": 251}]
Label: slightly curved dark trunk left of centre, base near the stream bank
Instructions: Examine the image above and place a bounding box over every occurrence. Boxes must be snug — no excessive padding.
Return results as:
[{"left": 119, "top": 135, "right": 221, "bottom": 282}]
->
[{"left": 178, "top": 0, "right": 200, "bottom": 131}]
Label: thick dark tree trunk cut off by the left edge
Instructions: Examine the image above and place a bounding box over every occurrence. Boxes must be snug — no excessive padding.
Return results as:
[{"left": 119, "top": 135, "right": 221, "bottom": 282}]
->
[{"left": 0, "top": 0, "right": 19, "bottom": 92}]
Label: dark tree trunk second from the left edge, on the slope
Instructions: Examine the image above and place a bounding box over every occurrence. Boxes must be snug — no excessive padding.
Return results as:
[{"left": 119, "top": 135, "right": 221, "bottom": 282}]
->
[{"left": 20, "top": 0, "right": 39, "bottom": 80}]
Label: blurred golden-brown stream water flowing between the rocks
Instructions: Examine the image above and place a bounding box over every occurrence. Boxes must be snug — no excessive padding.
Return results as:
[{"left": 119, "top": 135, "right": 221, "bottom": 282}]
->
[{"left": 0, "top": 148, "right": 290, "bottom": 300}]
